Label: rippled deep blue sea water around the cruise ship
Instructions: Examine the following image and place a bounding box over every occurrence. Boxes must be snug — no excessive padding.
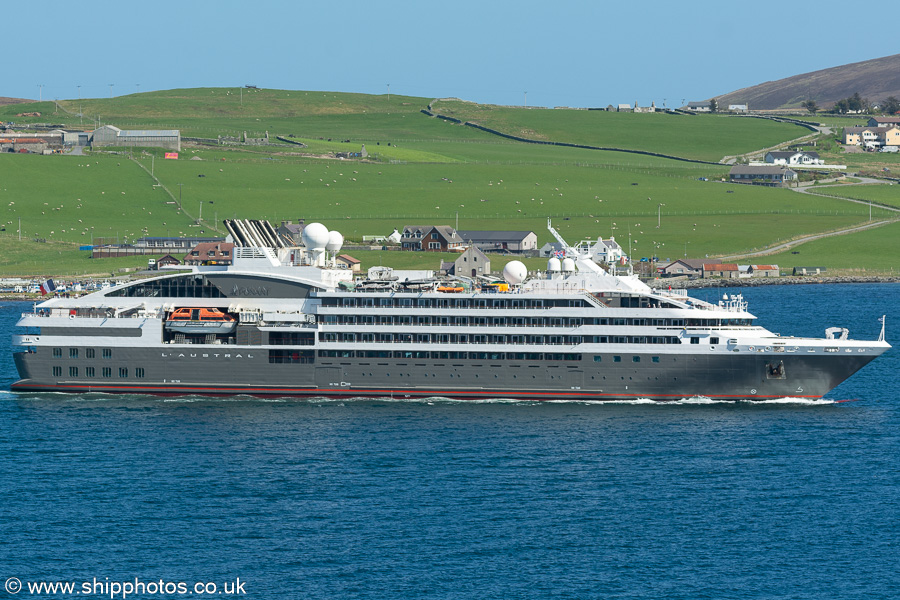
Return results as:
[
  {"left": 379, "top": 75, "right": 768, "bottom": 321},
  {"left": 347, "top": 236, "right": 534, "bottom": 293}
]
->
[{"left": 0, "top": 284, "right": 900, "bottom": 600}]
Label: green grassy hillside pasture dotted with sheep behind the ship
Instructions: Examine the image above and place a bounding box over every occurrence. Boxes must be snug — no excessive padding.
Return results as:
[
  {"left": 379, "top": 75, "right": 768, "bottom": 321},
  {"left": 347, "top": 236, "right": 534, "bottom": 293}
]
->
[{"left": 0, "top": 89, "right": 900, "bottom": 273}]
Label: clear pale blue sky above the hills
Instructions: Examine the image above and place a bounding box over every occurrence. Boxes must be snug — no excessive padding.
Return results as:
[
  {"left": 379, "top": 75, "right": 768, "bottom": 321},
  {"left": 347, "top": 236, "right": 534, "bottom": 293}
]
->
[{"left": 8, "top": 0, "right": 900, "bottom": 107}]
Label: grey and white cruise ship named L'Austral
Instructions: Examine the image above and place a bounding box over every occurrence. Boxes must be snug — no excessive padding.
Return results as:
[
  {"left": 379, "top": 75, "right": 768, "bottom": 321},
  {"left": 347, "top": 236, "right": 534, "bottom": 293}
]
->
[{"left": 12, "top": 220, "right": 890, "bottom": 401}]
